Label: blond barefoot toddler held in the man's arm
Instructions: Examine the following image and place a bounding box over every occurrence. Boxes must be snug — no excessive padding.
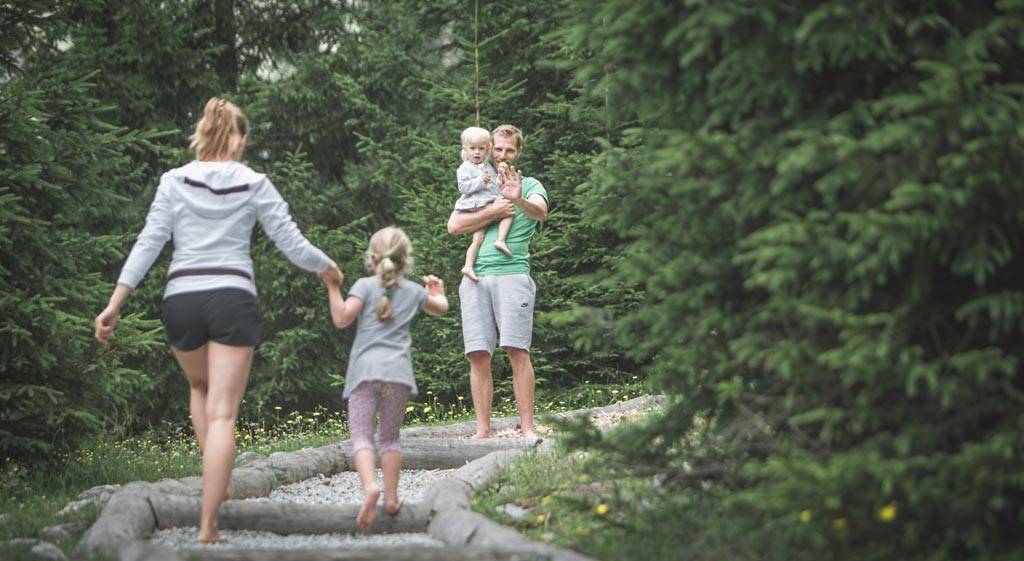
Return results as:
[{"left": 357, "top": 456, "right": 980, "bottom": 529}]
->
[{"left": 455, "top": 127, "right": 512, "bottom": 283}]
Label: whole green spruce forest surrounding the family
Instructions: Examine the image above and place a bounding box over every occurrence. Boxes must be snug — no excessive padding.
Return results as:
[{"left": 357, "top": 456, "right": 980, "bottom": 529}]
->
[{"left": 0, "top": 0, "right": 1024, "bottom": 560}]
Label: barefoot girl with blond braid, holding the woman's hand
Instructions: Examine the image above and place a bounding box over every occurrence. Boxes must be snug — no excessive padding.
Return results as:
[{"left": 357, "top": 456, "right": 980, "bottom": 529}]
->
[{"left": 324, "top": 227, "right": 447, "bottom": 530}]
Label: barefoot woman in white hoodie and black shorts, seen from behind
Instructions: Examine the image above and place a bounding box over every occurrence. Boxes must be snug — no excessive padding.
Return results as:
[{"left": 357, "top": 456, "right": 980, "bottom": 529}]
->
[{"left": 95, "top": 97, "right": 341, "bottom": 543}]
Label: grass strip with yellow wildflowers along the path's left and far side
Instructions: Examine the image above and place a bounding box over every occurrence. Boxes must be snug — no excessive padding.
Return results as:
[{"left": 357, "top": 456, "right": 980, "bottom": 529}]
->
[{"left": 0, "top": 384, "right": 642, "bottom": 561}]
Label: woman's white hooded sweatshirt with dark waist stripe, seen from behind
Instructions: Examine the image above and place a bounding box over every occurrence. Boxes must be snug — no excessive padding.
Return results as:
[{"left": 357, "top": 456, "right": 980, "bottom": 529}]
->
[{"left": 118, "top": 160, "right": 331, "bottom": 298}]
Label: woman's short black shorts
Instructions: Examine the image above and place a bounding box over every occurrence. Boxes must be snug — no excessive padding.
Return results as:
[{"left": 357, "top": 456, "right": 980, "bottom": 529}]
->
[{"left": 163, "top": 289, "right": 263, "bottom": 351}]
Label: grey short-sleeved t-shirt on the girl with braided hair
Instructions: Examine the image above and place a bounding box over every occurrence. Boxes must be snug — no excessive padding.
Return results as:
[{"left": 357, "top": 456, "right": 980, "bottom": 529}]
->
[{"left": 342, "top": 274, "right": 427, "bottom": 399}]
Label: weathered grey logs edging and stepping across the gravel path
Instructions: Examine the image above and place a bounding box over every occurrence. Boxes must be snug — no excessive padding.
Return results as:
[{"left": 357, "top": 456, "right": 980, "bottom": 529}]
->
[{"left": 79, "top": 396, "right": 664, "bottom": 561}]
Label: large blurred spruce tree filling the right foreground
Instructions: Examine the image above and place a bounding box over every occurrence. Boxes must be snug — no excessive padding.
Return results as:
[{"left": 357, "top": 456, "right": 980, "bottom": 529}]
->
[{"left": 565, "top": 1, "right": 1024, "bottom": 559}]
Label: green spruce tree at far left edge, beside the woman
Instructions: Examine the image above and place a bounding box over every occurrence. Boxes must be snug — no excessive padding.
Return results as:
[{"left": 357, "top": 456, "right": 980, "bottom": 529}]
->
[{"left": 0, "top": 72, "right": 167, "bottom": 458}]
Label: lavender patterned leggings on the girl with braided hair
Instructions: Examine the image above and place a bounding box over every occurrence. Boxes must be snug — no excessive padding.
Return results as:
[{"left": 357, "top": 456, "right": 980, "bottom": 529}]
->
[{"left": 348, "top": 381, "right": 410, "bottom": 452}]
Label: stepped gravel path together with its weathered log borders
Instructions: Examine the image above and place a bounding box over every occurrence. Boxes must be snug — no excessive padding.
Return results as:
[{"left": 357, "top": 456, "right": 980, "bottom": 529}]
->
[{"left": 80, "top": 397, "right": 659, "bottom": 561}]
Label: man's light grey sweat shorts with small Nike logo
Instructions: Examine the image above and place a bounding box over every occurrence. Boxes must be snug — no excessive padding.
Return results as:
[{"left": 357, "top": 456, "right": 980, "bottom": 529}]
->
[{"left": 459, "top": 274, "right": 537, "bottom": 354}]
